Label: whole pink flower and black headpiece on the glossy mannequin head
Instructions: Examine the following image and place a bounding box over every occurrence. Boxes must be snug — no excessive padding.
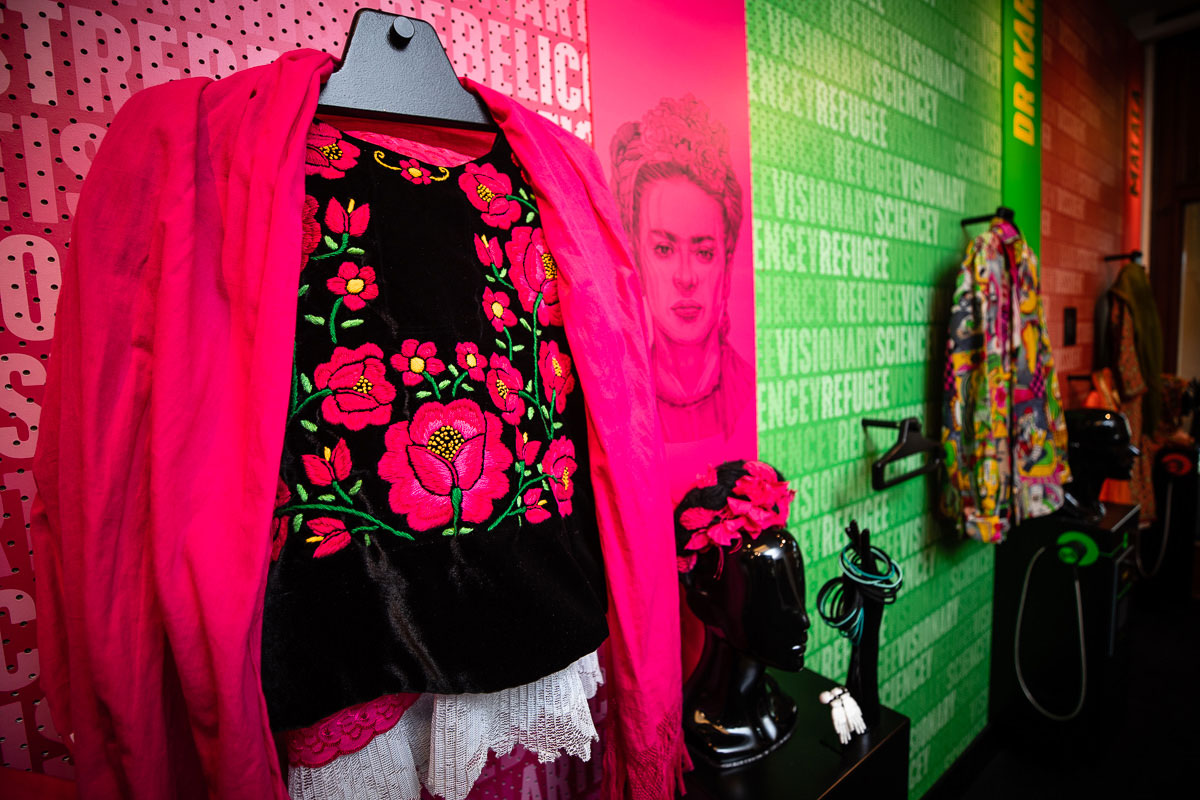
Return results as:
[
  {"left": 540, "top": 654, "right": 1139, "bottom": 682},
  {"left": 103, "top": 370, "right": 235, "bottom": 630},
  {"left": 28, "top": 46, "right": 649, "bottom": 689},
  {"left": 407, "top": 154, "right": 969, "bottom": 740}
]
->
[{"left": 676, "top": 461, "right": 796, "bottom": 577}]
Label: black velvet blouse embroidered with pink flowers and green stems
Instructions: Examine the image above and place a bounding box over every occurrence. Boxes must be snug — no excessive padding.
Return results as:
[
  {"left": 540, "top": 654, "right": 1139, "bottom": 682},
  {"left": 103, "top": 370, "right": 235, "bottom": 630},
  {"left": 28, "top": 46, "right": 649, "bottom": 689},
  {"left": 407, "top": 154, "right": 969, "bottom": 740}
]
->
[{"left": 263, "top": 121, "right": 607, "bottom": 728}]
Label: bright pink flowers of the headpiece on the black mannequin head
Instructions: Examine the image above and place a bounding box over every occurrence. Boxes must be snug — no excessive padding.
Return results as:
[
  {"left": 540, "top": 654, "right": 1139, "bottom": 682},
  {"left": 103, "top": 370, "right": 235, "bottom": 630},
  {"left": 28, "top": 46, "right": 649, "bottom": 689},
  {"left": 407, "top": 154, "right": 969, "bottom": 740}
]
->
[{"left": 678, "top": 461, "right": 796, "bottom": 576}]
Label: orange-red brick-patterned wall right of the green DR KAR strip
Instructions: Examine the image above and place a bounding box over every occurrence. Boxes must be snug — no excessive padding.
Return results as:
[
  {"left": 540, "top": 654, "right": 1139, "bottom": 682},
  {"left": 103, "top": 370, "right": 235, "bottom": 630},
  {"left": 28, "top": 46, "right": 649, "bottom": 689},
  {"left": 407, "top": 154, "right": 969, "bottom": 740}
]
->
[{"left": 1039, "top": 0, "right": 1141, "bottom": 405}]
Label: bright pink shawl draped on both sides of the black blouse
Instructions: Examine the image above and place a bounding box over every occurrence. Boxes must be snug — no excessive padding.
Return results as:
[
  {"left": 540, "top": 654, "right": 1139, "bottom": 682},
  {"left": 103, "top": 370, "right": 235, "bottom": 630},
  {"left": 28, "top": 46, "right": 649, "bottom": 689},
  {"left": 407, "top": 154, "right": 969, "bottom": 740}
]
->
[{"left": 32, "top": 50, "right": 686, "bottom": 800}]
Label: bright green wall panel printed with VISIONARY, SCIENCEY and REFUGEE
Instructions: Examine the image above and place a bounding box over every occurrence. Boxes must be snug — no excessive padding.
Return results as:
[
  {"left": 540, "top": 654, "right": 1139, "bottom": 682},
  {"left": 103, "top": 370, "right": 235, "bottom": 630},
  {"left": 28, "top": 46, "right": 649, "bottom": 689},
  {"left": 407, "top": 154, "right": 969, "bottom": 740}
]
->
[{"left": 746, "top": 0, "right": 1002, "bottom": 796}]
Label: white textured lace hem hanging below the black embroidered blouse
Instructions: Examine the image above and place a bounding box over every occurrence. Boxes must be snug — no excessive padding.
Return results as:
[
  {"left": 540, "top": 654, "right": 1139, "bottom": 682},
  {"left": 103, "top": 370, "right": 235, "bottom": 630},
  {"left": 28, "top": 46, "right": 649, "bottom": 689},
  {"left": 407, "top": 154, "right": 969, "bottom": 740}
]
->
[{"left": 288, "top": 652, "right": 604, "bottom": 800}]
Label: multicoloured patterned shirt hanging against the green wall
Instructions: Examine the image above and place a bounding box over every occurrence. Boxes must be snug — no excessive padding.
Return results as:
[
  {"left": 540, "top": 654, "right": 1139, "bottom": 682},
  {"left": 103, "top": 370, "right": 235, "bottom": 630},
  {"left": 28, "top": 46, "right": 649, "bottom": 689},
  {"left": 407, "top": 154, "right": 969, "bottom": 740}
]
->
[{"left": 942, "top": 221, "right": 1070, "bottom": 542}]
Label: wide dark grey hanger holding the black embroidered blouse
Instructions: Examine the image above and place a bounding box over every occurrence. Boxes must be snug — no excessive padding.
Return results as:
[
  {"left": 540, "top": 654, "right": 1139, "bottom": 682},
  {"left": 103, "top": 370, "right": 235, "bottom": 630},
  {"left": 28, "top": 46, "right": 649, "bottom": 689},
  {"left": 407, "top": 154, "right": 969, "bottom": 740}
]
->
[{"left": 317, "top": 8, "right": 497, "bottom": 131}]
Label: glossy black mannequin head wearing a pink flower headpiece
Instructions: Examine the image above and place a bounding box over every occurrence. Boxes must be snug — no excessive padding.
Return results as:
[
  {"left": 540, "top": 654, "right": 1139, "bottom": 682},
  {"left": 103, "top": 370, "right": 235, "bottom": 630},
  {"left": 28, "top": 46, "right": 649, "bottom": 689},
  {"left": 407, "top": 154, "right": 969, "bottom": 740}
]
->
[{"left": 676, "top": 461, "right": 809, "bottom": 768}]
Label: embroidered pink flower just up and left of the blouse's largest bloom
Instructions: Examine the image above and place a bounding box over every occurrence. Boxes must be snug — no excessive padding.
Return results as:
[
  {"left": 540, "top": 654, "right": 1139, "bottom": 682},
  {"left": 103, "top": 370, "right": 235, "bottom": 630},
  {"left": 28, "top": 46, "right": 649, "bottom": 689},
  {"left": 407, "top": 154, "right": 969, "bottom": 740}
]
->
[{"left": 313, "top": 343, "right": 396, "bottom": 431}]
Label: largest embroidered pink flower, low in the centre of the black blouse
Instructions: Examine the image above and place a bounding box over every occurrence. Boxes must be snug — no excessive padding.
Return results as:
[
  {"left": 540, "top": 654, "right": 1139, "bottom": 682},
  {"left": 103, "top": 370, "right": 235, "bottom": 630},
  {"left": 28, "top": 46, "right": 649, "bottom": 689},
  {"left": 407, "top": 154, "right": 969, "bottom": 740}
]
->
[{"left": 379, "top": 399, "right": 512, "bottom": 530}]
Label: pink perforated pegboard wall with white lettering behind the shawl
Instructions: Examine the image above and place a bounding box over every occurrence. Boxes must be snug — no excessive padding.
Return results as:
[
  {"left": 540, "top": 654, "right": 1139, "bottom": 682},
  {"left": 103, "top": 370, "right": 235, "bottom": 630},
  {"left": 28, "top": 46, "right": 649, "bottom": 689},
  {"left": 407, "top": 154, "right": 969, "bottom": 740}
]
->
[{"left": 0, "top": 0, "right": 600, "bottom": 800}]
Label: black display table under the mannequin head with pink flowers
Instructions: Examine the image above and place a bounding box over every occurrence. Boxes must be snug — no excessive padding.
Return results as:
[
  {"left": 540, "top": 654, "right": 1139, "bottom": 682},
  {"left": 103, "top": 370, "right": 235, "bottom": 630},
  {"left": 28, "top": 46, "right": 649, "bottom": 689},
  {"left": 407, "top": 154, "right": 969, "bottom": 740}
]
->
[{"left": 685, "top": 670, "right": 910, "bottom": 800}]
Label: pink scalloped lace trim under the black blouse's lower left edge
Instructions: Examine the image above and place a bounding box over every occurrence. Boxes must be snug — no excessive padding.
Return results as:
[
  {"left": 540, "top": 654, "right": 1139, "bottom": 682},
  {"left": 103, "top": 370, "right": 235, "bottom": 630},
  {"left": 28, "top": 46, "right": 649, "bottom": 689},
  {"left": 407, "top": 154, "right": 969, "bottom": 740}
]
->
[{"left": 284, "top": 694, "right": 420, "bottom": 766}]
